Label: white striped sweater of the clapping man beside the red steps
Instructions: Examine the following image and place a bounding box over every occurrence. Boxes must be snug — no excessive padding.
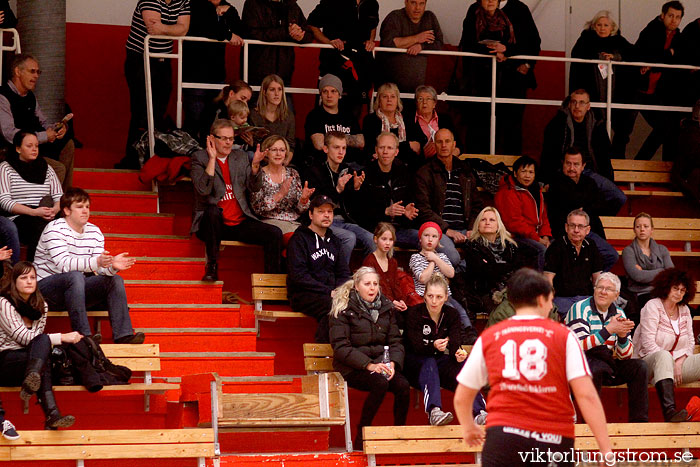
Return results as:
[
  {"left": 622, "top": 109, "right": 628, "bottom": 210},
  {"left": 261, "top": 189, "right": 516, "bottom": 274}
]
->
[{"left": 34, "top": 218, "right": 117, "bottom": 280}]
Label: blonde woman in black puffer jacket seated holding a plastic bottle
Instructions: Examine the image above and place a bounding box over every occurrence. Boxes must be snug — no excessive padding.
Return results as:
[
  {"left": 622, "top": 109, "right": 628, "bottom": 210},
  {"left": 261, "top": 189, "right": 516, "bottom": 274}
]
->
[{"left": 330, "top": 266, "right": 410, "bottom": 450}]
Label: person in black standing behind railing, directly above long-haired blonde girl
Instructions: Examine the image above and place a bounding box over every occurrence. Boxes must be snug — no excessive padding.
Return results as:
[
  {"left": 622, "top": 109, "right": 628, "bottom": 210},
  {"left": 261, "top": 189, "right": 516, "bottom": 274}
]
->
[{"left": 243, "top": 0, "right": 313, "bottom": 86}]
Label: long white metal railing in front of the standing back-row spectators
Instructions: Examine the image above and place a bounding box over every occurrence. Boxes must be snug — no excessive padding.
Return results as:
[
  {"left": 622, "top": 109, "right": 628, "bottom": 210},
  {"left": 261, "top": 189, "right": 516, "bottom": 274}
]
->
[{"left": 144, "top": 35, "right": 700, "bottom": 155}]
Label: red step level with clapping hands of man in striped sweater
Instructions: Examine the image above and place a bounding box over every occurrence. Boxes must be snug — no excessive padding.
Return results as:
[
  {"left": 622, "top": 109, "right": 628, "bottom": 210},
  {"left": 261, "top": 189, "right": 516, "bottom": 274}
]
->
[{"left": 120, "top": 256, "right": 206, "bottom": 281}]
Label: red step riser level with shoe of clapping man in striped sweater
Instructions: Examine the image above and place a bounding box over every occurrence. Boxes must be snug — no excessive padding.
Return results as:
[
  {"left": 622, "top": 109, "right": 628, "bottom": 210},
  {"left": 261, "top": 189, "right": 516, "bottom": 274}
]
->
[{"left": 134, "top": 328, "right": 256, "bottom": 352}]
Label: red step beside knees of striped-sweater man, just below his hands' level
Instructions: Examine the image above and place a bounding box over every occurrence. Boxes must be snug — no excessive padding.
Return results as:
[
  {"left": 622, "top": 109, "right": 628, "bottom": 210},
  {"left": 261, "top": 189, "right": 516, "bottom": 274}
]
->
[{"left": 124, "top": 280, "right": 224, "bottom": 304}]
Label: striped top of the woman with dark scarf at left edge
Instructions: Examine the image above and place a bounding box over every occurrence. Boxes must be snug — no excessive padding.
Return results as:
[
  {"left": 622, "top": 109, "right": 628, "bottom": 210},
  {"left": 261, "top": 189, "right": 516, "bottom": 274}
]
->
[{"left": 0, "top": 162, "right": 63, "bottom": 219}]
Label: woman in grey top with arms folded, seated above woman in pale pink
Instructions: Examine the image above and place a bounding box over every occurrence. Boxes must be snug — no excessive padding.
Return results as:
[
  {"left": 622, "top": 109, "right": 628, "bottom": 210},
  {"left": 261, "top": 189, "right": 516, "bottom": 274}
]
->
[{"left": 622, "top": 212, "right": 673, "bottom": 308}]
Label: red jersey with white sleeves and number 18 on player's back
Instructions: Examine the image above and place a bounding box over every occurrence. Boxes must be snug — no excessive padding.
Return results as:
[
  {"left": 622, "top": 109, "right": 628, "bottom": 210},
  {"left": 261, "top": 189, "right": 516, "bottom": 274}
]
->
[{"left": 457, "top": 316, "right": 590, "bottom": 438}]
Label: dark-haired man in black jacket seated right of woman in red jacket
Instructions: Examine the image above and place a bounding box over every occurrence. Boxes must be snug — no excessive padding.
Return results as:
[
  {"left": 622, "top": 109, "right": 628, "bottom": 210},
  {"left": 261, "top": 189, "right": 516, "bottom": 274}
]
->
[{"left": 545, "top": 146, "right": 619, "bottom": 272}]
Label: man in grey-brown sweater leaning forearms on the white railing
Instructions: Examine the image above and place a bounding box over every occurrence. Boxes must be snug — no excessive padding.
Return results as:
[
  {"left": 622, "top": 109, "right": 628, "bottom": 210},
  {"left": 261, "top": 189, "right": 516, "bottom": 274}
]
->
[{"left": 379, "top": 0, "right": 443, "bottom": 92}]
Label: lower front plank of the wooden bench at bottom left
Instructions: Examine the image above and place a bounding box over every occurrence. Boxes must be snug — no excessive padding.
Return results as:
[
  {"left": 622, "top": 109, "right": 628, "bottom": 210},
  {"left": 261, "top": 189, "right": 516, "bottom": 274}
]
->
[{"left": 9, "top": 443, "right": 215, "bottom": 461}]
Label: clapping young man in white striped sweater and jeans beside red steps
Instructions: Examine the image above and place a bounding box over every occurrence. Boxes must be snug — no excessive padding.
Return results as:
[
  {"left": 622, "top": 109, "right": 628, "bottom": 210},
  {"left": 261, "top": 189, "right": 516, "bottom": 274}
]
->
[{"left": 34, "top": 188, "right": 145, "bottom": 344}]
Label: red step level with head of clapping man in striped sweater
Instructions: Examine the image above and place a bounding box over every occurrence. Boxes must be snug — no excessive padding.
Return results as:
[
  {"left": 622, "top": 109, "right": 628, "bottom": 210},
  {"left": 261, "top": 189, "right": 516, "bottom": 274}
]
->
[{"left": 90, "top": 211, "right": 174, "bottom": 235}]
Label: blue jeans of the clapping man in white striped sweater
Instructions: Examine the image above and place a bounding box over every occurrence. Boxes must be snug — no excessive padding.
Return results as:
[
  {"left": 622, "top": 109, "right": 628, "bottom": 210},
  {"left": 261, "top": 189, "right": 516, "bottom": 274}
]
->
[{"left": 39, "top": 271, "right": 134, "bottom": 340}]
